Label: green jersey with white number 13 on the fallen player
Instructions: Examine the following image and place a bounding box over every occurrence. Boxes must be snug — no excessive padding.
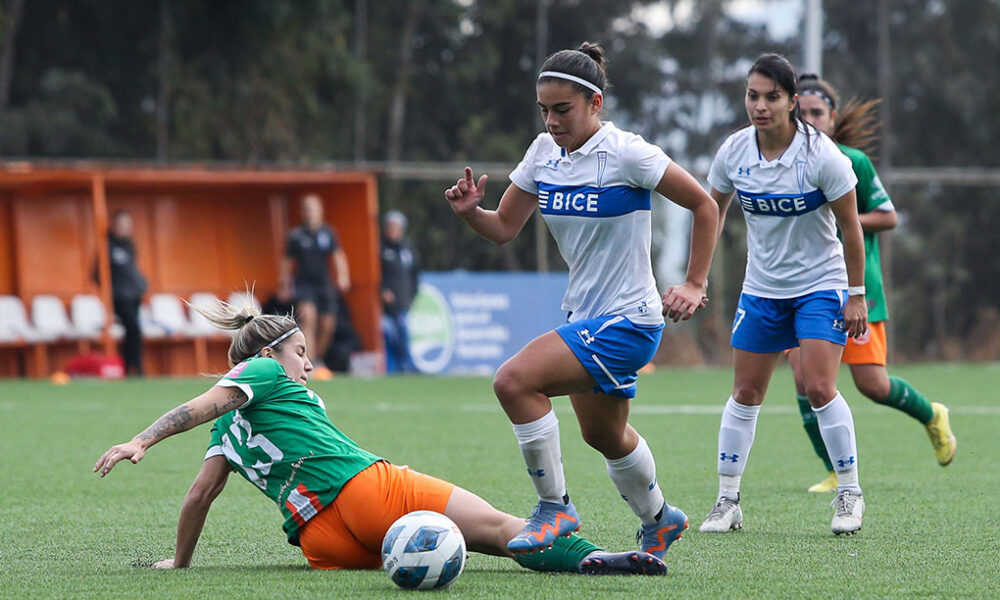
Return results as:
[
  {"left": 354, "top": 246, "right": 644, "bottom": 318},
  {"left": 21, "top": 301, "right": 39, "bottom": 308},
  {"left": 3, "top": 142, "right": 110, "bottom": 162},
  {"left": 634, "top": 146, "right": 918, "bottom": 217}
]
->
[{"left": 205, "top": 357, "right": 381, "bottom": 545}]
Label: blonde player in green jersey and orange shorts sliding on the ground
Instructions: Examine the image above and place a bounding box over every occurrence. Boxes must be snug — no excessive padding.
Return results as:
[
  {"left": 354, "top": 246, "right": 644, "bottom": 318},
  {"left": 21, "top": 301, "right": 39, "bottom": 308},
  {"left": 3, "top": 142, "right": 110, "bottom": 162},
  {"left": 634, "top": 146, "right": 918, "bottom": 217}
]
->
[{"left": 94, "top": 302, "right": 667, "bottom": 575}]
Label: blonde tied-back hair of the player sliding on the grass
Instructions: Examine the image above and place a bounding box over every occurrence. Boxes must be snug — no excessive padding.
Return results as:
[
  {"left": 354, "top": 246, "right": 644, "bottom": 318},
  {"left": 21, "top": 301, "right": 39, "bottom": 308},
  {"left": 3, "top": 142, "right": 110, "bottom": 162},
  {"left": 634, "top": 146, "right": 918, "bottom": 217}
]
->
[{"left": 188, "top": 300, "right": 298, "bottom": 367}]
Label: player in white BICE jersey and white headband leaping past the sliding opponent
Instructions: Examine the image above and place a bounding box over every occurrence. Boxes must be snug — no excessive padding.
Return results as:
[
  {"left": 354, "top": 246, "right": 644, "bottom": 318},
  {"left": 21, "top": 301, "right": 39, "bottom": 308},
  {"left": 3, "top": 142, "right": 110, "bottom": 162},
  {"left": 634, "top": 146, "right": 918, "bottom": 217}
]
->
[{"left": 445, "top": 43, "right": 718, "bottom": 557}]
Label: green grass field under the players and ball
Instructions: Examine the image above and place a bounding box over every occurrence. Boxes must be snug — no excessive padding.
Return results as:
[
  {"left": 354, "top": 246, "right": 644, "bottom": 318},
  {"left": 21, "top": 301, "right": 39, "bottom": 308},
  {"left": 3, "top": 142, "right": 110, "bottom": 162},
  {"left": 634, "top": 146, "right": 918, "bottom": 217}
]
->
[{"left": 0, "top": 365, "right": 1000, "bottom": 599}]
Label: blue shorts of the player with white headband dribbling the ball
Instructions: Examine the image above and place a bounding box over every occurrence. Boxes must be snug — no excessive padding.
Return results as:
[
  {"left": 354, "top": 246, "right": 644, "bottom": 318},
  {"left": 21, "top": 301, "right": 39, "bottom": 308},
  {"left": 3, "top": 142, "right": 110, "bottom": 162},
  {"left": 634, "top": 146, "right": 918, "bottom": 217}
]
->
[{"left": 556, "top": 315, "right": 663, "bottom": 398}]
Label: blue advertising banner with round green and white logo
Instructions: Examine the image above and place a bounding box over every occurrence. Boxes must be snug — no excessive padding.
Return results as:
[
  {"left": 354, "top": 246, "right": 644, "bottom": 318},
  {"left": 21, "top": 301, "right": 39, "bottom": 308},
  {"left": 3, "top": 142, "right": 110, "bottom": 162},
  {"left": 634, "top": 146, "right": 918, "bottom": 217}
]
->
[{"left": 407, "top": 271, "right": 568, "bottom": 375}]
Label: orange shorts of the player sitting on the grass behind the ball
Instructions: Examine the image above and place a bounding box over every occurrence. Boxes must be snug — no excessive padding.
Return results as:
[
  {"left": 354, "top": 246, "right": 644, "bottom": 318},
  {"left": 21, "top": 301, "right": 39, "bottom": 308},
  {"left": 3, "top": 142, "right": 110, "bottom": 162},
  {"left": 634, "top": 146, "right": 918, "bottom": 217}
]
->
[{"left": 299, "top": 461, "right": 455, "bottom": 569}]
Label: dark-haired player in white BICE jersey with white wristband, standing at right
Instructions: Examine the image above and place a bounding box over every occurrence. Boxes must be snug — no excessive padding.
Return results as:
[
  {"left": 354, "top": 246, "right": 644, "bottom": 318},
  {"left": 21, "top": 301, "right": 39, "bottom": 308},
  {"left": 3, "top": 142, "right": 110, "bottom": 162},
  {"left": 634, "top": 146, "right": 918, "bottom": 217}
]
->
[{"left": 700, "top": 54, "right": 868, "bottom": 535}]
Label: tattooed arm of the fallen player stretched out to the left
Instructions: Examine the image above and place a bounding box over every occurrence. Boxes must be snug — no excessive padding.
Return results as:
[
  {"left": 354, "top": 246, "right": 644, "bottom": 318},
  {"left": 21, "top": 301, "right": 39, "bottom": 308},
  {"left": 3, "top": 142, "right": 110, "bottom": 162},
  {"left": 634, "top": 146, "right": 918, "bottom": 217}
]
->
[{"left": 94, "top": 386, "right": 247, "bottom": 477}]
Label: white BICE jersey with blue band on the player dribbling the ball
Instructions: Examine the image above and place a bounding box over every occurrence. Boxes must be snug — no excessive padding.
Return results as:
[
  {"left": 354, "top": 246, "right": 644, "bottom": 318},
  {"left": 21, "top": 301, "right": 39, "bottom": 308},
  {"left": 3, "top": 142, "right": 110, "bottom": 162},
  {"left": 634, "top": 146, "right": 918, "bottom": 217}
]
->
[{"left": 510, "top": 123, "right": 670, "bottom": 325}]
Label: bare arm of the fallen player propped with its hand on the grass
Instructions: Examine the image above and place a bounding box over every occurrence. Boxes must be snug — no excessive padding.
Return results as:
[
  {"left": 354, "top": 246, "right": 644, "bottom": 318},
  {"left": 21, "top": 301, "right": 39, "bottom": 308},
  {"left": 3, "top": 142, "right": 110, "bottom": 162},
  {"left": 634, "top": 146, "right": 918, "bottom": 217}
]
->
[{"left": 153, "top": 454, "right": 232, "bottom": 569}]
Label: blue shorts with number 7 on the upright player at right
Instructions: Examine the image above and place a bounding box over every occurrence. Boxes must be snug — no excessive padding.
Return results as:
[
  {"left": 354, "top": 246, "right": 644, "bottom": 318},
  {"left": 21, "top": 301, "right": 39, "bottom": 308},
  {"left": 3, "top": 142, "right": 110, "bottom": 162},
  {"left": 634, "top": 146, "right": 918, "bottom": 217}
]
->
[{"left": 730, "top": 290, "right": 847, "bottom": 353}]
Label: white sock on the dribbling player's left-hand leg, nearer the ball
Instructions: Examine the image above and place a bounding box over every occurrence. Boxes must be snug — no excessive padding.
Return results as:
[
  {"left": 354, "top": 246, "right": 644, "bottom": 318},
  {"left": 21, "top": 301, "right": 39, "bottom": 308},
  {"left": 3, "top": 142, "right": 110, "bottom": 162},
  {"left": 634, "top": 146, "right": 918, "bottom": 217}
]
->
[{"left": 513, "top": 410, "right": 566, "bottom": 504}]
